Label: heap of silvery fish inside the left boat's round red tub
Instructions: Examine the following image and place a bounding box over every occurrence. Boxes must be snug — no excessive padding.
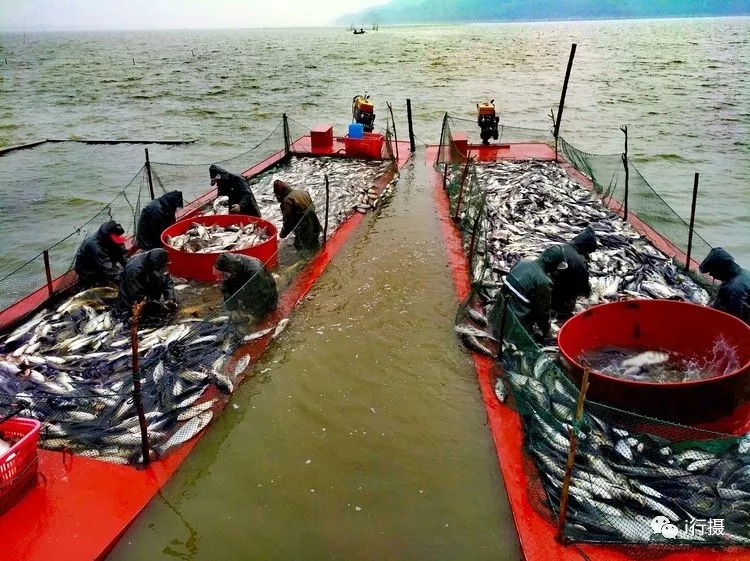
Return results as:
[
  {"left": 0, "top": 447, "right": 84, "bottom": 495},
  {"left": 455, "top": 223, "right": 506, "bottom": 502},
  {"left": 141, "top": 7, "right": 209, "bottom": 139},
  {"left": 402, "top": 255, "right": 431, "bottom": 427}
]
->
[{"left": 165, "top": 222, "right": 270, "bottom": 253}]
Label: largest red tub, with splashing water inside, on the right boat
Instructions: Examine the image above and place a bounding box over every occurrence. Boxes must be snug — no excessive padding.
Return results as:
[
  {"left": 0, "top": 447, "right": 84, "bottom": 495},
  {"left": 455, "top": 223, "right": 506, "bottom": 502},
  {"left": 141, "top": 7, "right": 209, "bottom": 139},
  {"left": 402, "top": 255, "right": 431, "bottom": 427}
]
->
[{"left": 558, "top": 300, "right": 750, "bottom": 425}]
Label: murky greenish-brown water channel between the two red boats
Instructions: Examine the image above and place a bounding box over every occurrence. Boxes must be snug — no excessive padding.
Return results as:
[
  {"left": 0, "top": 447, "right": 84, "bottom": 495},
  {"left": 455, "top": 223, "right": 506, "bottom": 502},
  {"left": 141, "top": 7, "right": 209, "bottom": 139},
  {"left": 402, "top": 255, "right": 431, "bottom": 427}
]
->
[{"left": 109, "top": 150, "right": 519, "bottom": 560}]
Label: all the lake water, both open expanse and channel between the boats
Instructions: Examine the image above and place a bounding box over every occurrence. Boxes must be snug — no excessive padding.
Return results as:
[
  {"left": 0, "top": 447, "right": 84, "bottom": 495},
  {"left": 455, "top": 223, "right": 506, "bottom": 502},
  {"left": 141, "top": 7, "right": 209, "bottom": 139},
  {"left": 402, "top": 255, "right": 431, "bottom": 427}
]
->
[{"left": 0, "top": 18, "right": 750, "bottom": 559}]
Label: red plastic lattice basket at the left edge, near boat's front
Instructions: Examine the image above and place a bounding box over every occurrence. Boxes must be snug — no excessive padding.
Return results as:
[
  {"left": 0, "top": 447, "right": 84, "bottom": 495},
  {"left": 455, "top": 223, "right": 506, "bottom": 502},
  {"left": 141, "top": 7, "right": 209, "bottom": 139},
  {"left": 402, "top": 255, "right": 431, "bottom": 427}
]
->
[{"left": 0, "top": 417, "right": 42, "bottom": 513}]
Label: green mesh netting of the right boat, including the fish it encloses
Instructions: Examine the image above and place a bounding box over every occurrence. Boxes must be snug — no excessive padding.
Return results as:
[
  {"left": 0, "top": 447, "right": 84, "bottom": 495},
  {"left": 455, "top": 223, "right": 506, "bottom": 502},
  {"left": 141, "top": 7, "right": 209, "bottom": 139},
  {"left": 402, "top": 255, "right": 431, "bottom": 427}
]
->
[{"left": 435, "top": 116, "right": 750, "bottom": 548}]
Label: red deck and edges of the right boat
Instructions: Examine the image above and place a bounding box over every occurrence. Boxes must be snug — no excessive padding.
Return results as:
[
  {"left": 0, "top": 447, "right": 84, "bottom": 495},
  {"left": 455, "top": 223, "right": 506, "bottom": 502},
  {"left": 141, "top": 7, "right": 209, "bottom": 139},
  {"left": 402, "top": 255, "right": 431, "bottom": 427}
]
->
[{"left": 426, "top": 144, "right": 750, "bottom": 561}]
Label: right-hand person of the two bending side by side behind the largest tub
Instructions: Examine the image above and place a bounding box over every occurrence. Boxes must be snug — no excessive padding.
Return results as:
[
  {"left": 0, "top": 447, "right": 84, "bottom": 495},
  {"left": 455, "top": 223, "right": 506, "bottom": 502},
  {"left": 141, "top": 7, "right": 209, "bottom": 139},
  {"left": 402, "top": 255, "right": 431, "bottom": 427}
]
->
[{"left": 542, "top": 226, "right": 599, "bottom": 319}]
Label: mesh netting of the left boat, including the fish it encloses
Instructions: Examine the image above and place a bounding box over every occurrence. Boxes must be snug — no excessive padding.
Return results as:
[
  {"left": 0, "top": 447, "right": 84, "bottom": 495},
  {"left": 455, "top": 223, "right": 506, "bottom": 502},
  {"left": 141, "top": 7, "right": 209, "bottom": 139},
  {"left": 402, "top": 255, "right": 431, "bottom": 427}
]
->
[{"left": 0, "top": 112, "right": 396, "bottom": 464}]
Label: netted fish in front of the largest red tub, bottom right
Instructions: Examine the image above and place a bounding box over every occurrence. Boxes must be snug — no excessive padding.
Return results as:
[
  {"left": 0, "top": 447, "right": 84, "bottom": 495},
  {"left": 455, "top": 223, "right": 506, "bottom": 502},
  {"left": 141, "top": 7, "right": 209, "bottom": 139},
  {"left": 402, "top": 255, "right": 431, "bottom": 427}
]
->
[{"left": 495, "top": 353, "right": 750, "bottom": 546}]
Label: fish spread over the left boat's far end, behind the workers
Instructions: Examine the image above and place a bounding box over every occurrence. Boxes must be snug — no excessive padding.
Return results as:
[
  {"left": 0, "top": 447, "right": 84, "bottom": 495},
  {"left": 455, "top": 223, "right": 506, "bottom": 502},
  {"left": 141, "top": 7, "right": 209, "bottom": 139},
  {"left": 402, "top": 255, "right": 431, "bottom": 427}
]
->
[{"left": 202, "top": 156, "right": 398, "bottom": 232}]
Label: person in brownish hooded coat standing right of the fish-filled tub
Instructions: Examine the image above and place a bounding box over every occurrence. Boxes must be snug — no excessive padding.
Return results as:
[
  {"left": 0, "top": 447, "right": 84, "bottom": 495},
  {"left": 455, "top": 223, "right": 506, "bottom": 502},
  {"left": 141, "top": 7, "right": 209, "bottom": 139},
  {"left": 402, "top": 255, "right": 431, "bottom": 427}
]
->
[{"left": 273, "top": 179, "right": 323, "bottom": 251}]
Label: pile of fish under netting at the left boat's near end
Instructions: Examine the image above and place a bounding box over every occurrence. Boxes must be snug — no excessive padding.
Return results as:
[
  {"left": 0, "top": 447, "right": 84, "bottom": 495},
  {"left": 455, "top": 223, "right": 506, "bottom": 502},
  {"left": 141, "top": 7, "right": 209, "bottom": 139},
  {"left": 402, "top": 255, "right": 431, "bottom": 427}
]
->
[{"left": 0, "top": 288, "right": 278, "bottom": 464}]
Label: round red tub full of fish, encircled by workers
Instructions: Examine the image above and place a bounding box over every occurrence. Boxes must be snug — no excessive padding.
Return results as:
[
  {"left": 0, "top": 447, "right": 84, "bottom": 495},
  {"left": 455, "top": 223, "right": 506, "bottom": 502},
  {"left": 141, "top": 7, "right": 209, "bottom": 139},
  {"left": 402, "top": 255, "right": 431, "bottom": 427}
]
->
[{"left": 161, "top": 214, "right": 279, "bottom": 282}]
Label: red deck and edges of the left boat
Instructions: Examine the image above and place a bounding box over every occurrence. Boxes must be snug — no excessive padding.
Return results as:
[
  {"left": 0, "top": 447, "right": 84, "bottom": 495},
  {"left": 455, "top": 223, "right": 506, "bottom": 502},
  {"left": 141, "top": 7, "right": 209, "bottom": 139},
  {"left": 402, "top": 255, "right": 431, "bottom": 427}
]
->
[{"left": 0, "top": 137, "right": 411, "bottom": 561}]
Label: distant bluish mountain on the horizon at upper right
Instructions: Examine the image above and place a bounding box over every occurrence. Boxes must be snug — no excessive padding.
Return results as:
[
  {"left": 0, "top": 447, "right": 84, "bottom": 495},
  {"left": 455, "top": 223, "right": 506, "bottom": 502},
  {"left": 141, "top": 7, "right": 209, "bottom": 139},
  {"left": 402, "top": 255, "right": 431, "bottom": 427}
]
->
[{"left": 335, "top": 0, "right": 750, "bottom": 25}]
